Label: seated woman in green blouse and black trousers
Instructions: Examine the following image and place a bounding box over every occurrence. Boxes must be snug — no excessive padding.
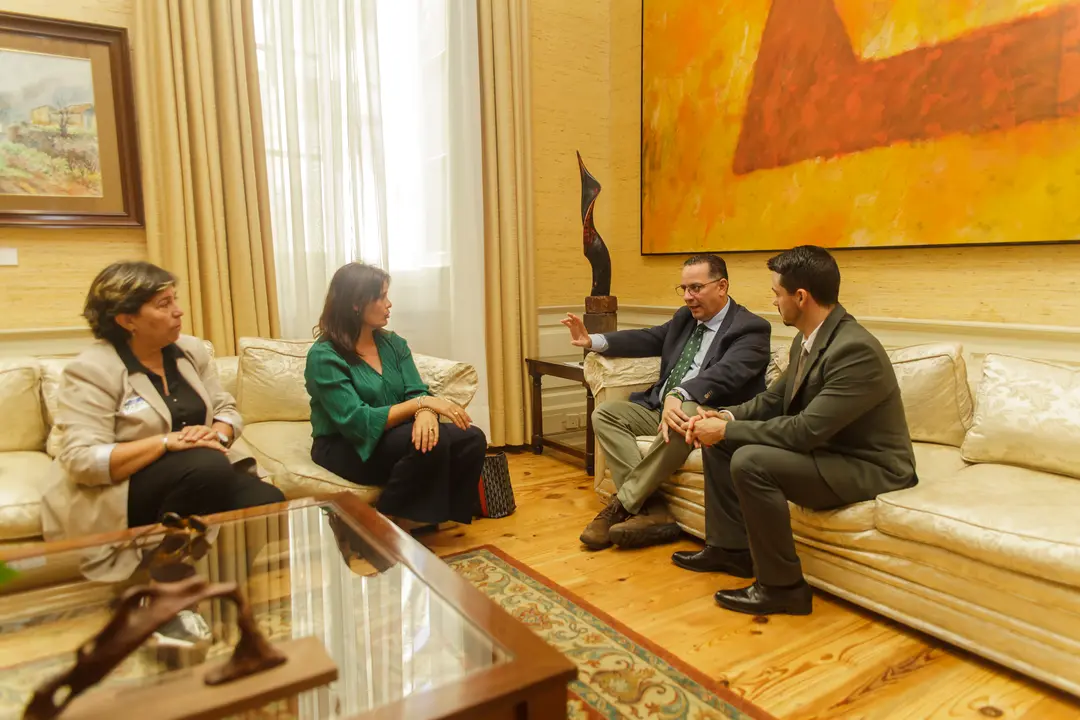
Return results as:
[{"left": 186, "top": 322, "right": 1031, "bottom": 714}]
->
[{"left": 303, "top": 262, "right": 487, "bottom": 524}]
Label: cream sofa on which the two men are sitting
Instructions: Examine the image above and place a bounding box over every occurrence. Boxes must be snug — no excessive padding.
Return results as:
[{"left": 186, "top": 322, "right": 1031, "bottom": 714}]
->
[{"left": 585, "top": 343, "right": 1080, "bottom": 695}]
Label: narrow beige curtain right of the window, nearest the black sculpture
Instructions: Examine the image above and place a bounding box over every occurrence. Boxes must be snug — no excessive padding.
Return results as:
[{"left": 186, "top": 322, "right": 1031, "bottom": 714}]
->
[{"left": 477, "top": 0, "right": 537, "bottom": 446}]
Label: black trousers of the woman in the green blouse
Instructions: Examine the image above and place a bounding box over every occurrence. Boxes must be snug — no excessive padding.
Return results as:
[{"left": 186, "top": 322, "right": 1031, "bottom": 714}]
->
[{"left": 311, "top": 422, "right": 487, "bottom": 525}]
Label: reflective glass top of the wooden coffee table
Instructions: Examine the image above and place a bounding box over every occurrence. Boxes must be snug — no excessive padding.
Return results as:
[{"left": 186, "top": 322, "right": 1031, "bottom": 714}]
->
[{"left": 0, "top": 505, "right": 512, "bottom": 718}]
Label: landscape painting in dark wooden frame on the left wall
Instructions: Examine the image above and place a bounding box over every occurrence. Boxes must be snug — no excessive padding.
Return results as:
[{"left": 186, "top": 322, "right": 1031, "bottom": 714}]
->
[{"left": 0, "top": 13, "right": 143, "bottom": 227}]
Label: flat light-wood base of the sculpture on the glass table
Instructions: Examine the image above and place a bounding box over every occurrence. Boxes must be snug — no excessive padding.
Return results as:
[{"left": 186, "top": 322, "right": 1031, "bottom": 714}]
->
[{"left": 64, "top": 637, "right": 338, "bottom": 720}]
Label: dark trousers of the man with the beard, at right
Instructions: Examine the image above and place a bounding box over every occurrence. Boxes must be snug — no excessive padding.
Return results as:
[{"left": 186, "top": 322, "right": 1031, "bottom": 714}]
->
[{"left": 703, "top": 443, "right": 847, "bottom": 585}]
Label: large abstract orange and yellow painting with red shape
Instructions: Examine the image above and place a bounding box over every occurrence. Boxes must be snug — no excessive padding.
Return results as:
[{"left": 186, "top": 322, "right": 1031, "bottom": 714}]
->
[{"left": 642, "top": 0, "right": 1080, "bottom": 255}]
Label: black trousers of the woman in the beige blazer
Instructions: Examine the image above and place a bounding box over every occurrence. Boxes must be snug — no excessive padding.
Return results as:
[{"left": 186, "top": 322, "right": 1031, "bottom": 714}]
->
[{"left": 127, "top": 448, "right": 285, "bottom": 528}]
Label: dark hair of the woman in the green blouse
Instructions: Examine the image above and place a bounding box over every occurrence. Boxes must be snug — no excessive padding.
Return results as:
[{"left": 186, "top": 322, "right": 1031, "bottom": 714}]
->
[{"left": 314, "top": 262, "right": 390, "bottom": 363}]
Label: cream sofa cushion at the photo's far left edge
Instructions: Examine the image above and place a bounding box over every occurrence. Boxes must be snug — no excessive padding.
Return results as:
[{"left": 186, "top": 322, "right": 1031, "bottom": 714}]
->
[{"left": 0, "top": 357, "right": 49, "bottom": 452}]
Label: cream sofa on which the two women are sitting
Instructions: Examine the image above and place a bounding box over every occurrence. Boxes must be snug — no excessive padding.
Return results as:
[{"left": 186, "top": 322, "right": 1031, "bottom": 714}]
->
[{"left": 0, "top": 338, "right": 477, "bottom": 543}]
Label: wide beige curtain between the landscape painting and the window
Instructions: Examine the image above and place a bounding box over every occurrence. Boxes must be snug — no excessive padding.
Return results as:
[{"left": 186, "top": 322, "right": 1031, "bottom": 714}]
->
[{"left": 134, "top": 0, "right": 279, "bottom": 355}]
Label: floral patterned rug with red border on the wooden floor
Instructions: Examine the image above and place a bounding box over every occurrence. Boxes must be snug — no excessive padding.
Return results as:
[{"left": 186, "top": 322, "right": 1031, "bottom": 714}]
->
[{"left": 443, "top": 546, "right": 772, "bottom": 720}]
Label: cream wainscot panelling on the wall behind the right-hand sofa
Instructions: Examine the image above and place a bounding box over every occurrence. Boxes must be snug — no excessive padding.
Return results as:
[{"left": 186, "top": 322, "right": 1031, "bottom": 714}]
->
[{"left": 537, "top": 305, "right": 1080, "bottom": 430}]
